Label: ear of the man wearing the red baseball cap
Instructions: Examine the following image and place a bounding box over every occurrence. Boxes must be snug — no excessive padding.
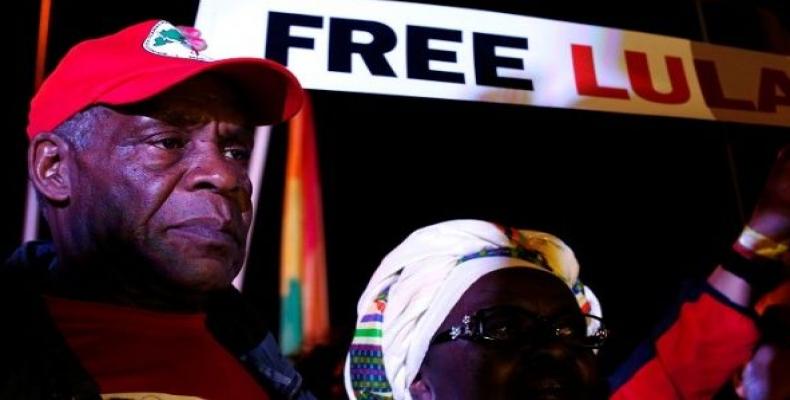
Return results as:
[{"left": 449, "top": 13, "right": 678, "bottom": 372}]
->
[{"left": 27, "top": 133, "right": 73, "bottom": 203}]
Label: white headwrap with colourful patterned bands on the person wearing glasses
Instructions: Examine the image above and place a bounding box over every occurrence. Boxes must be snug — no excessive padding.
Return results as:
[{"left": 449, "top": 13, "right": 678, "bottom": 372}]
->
[{"left": 345, "top": 220, "right": 601, "bottom": 400}]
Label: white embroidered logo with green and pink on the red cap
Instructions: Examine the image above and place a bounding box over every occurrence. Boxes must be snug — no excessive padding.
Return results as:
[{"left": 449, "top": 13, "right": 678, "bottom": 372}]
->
[{"left": 143, "top": 21, "right": 211, "bottom": 61}]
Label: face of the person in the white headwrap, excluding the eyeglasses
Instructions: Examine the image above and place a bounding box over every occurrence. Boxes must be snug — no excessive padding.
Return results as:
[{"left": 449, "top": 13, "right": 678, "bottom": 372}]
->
[{"left": 418, "top": 268, "right": 599, "bottom": 400}]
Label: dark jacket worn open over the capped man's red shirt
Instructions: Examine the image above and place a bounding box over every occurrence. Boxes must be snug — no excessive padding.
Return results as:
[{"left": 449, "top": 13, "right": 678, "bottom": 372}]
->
[{"left": 0, "top": 242, "right": 314, "bottom": 400}]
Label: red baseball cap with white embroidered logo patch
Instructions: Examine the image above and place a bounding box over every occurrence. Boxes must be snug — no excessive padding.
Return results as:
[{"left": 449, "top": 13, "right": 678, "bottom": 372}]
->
[{"left": 27, "top": 20, "right": 304, "bottom": 138}]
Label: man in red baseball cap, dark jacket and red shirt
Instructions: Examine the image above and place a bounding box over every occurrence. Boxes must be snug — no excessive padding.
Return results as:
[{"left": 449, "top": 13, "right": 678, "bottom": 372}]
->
[{"left": 0, "top": 21, "right": 312, "bottom": 399}]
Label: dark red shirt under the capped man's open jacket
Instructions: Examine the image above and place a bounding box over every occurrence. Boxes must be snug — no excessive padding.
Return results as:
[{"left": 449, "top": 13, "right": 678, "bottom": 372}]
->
[{"left": 46, "top": 297, "right": 269, "bottom": 400}]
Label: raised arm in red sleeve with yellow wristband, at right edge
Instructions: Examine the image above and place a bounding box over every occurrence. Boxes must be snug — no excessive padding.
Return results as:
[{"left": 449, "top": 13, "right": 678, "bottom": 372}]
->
[{"left": 610, "top": 148, "right": 790, "bottom": 399}]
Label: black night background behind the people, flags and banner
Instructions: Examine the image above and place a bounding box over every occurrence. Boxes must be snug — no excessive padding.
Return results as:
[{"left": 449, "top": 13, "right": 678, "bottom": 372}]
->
[{"left": 6, "top": 0, "right": 790, "bottom": 388}]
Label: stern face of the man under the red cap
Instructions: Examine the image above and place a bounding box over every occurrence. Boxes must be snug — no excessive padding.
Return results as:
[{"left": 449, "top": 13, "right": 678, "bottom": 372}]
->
[{"left": 71, "top": 77, "right": 253, "bottom": 291}]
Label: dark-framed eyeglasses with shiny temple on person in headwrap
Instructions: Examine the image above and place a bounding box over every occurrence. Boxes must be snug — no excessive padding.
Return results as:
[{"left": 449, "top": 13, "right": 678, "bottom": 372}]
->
[{"left": 430, "top": 306, "right": 609, "bottom": 349}]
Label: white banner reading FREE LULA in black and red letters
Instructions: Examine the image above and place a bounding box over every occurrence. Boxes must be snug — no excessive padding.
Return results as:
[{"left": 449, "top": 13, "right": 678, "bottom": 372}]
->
[{"left": 196, "top": 0, "right": 790, "bottom": 126}]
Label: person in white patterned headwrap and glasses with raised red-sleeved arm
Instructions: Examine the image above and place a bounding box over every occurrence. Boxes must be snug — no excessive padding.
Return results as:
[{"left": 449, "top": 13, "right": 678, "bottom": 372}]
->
[{"left": 345, "top": 151, "right": 790, "bottom": 400}]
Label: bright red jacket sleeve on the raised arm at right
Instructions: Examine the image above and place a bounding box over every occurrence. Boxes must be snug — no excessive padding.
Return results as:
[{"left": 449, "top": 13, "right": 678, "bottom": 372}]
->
[{"left": 609, "top": 284, "right": 758, "bottom": 400}]
